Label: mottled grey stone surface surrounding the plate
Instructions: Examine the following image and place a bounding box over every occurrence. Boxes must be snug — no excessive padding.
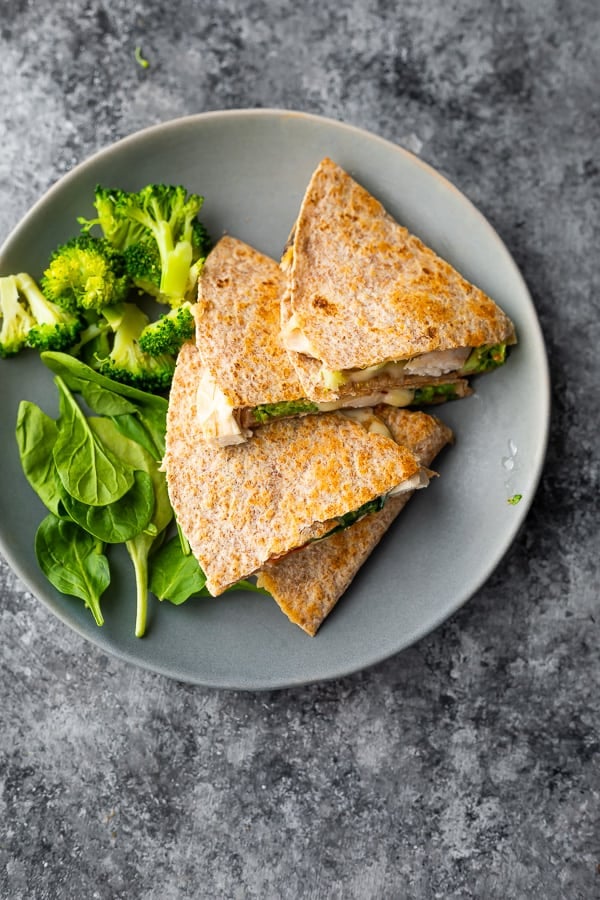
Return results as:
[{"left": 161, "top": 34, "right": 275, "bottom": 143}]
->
[{"left": 0, "top": 0, "right": 600, "bottom": 900}]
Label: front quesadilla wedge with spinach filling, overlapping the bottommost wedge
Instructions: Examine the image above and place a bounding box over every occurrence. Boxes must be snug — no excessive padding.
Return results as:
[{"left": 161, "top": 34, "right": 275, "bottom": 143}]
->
[{"left": 163, "top": 342, "right": 433, "bottom": 595}]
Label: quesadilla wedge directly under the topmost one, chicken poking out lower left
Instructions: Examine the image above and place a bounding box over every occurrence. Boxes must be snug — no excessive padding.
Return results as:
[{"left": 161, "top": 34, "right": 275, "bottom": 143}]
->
[{"left": 194, "top": 236, "right": 469, "bottom": 446}]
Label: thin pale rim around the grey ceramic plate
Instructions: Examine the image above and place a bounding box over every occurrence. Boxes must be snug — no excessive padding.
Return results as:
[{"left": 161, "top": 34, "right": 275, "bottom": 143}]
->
[{"left": 0, "top": 107, "right": 551, "bottom": 691}]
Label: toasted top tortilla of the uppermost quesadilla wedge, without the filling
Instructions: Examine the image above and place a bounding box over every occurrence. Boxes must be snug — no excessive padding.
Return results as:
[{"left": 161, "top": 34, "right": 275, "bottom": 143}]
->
[{"left": 284, "top": 158, "right": 516, "bottom": 377}]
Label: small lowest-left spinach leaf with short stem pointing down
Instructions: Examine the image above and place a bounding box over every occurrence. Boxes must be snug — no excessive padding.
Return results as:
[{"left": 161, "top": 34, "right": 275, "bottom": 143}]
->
[{"left": 35, "top": 515, "right": 110, "bottom": 625}]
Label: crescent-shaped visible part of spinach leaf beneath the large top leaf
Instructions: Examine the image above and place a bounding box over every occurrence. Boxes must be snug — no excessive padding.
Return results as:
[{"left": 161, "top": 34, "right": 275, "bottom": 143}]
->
[{"left": 62, "top": 471, "right": 156, "bottom": 544}]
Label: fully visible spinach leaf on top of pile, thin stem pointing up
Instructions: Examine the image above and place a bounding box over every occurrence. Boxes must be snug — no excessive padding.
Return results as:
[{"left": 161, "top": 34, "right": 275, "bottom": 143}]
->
[{"left": 53, "top": 376, "right": 133, "bottom": 506}]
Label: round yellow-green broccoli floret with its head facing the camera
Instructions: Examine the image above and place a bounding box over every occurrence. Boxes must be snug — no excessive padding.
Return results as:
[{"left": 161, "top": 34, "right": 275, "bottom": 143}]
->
[{"left": 41, "top": 233, "right": 132, "bottom": 311}]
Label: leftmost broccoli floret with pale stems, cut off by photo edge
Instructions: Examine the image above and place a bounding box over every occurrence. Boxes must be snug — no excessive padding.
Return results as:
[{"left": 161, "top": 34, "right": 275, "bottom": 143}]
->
[{"left": 0, "top": 272, "right": 83, "bottom": 356}]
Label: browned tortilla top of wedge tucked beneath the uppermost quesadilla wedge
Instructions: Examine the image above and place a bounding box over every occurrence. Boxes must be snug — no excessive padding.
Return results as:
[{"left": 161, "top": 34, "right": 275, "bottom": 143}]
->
[{"left": 194, "top": 235, "right": 304, "bottom": 408}]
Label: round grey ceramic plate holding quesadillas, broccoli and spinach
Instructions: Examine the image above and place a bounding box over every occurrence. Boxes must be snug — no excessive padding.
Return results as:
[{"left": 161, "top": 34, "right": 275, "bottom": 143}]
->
[{"left": 0, "top": 110, "right": 549, "bottom": 689}]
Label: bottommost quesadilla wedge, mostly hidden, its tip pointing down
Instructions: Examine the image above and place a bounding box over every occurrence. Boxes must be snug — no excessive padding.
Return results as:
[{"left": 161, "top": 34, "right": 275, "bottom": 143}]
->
[{"left": 257, "top": 407, "right": 452, "bottom": 636}]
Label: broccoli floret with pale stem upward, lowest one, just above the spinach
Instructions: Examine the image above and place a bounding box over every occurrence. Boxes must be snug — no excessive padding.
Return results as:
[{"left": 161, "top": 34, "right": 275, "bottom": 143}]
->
[{"left": 94, "top": 303, "right": 175, "bottom": 393}]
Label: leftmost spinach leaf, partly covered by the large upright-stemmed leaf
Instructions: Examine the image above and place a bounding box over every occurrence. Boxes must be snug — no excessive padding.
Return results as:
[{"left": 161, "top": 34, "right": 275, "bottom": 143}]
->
[{"left": 16, "top": 400, "right": 61, "bottom": 516}]
